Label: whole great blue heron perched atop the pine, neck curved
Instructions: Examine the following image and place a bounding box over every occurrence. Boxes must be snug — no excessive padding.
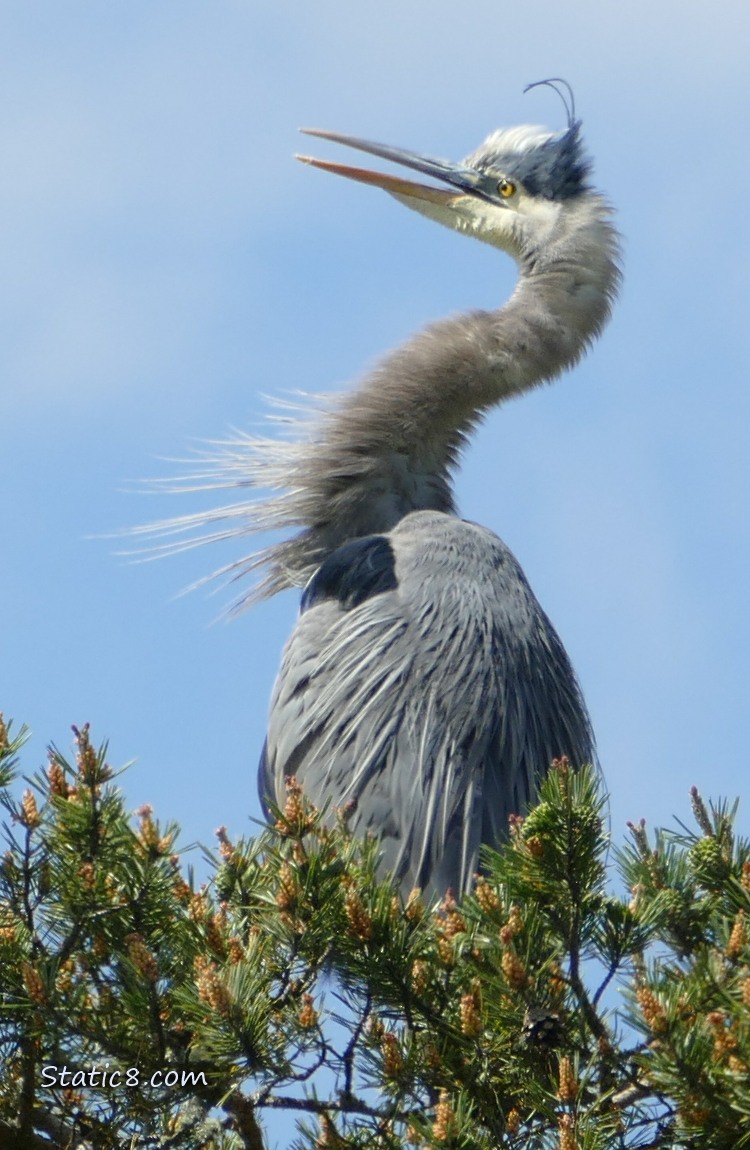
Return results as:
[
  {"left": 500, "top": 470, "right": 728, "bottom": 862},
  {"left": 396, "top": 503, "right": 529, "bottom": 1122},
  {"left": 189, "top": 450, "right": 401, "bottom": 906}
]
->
[{"left": 140, "top": 78, "right": 620, "bottom": 899}]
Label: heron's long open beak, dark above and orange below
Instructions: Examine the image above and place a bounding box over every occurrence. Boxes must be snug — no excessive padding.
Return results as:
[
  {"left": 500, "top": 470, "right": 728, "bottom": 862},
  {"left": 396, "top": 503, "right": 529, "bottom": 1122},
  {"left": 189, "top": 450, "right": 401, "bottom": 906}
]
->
[{"left": 297, "top": 128, "right": 487, "bottom": 207}]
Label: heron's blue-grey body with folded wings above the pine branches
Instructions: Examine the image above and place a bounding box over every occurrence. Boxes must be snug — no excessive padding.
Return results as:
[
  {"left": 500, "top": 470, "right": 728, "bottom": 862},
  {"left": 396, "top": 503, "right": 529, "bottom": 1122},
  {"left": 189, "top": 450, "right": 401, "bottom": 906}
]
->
[{"left": 260, "top": 512, "right": 592, "bottom": 895}]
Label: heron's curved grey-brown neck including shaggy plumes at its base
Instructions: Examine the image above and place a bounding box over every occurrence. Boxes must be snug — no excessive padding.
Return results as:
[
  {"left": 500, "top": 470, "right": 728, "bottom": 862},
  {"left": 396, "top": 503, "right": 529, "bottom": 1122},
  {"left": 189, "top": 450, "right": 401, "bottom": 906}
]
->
[{"left": 212, "top": 197, "right": 619, "bottom": 595}]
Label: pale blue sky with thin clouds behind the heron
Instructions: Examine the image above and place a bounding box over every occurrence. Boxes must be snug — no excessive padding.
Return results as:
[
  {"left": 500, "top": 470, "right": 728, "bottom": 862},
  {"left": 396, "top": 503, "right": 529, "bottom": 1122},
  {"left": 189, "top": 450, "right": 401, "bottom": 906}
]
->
[{"left": 0, "top": 0, "right": 750, "bottom": 878}]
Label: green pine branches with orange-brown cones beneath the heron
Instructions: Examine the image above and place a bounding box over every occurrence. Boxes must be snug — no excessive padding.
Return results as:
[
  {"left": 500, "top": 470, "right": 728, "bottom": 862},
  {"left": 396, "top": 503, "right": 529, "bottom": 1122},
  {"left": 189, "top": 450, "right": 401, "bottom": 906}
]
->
[{"left": 0, "top": 723, "right": 750, "bottom": 1150}]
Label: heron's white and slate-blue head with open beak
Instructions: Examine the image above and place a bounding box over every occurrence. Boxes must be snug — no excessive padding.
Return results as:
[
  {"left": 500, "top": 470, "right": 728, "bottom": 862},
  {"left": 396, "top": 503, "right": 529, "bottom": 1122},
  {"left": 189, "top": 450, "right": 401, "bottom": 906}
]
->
[{"left": 298, "top": 120, "right": 590, "bottom": 260}]
